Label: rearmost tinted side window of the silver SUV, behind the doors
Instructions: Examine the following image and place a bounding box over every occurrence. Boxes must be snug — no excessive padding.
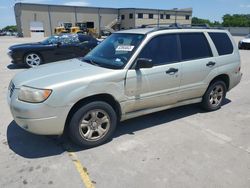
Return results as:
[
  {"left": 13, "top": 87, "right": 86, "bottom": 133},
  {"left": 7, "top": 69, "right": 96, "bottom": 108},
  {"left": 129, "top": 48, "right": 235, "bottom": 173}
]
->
[{"left": 208, "top": 33, "right": 233, "bottom": 55}]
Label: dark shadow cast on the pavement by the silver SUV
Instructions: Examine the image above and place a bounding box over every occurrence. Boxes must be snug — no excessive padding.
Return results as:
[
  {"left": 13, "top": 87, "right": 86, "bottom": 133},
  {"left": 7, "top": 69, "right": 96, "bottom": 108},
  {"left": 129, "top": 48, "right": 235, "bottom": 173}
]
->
[{"left": 7, "top": 99, "right": 231, "bottom": 158}]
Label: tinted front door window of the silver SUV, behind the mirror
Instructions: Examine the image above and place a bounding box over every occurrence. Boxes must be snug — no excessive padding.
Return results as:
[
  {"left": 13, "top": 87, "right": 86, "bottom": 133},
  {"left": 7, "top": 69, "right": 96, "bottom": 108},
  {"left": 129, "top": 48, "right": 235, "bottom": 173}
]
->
[{"left": 139, "top": 34, "right": 180, "bottom": 66}]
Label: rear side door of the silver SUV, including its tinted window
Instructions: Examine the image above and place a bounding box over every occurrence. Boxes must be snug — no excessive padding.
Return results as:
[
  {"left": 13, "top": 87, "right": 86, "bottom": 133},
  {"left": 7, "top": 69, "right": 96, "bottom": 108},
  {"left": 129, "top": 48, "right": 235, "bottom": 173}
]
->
[{"left": 179, "top": 32, "right": 217, "bottom": 101}]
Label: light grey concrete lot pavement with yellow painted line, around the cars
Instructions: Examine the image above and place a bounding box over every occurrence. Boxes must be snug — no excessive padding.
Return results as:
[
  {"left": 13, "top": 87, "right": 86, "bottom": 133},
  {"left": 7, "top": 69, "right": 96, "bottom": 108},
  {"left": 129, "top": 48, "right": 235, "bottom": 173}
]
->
[{"left": 0, "top": 37, "right": 250, "bottom": 188}]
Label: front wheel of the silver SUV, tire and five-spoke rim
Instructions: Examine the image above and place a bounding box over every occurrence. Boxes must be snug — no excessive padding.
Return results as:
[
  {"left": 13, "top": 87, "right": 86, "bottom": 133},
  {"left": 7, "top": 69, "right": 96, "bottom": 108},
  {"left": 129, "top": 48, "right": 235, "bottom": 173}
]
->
[{"left": 69, "top": 101, "right": 117, "bottom": 148}]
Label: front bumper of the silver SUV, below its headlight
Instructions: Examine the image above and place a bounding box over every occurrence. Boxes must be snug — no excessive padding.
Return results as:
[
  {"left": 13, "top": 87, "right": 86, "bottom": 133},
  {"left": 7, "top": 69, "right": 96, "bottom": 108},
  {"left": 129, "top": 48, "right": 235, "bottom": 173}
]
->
[{"left": 7, "top": 89, "right": 70, "bottom": 135}]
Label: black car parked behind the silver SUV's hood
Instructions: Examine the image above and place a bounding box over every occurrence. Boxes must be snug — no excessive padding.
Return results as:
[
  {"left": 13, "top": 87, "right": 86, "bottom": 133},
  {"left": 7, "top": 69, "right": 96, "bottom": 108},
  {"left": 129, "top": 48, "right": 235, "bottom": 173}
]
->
[{"left": 8, "top": 34, "right": 99, "bottom": 67}]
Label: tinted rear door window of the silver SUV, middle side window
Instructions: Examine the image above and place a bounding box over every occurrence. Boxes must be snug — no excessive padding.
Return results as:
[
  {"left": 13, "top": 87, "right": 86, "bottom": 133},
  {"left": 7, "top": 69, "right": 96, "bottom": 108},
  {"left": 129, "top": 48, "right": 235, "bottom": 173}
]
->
[{"left": 180, "top": 33, "right": 212, "bottom": 61}]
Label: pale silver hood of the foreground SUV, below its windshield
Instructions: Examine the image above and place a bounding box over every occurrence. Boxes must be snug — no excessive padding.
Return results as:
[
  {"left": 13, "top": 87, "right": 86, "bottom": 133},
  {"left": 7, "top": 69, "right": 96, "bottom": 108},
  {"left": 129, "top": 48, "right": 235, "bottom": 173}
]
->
[{"left": 12, "top": 59, "right": 117, "bottom": 89}]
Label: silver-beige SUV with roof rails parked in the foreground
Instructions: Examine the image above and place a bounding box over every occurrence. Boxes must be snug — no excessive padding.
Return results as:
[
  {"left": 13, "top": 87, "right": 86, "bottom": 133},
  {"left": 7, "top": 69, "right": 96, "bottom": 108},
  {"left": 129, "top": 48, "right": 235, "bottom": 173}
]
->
[{"left": 8, "top": 28, "right": 242, "bottom": 147}]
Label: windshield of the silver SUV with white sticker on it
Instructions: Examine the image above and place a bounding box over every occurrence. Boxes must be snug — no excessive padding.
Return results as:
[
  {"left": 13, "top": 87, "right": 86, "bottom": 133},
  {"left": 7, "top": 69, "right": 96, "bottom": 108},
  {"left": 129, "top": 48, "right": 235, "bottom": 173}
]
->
[{"left": 83, "top": 33, "right": 145, "bottom": 69}]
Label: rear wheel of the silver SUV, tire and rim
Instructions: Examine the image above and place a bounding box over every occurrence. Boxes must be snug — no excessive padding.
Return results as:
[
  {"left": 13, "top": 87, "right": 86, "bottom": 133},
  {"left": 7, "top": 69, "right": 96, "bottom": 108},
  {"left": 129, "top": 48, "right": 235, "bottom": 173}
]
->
[{"left": 202, "top": 81, "right": 227, "bottom": 111}]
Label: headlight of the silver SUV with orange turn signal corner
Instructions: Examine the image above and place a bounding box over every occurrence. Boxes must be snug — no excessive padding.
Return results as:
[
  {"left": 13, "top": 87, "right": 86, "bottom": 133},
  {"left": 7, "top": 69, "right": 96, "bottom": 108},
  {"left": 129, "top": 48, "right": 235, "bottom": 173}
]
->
[{"left": 18, "top": 86, "right": 52, "bottom": 103}]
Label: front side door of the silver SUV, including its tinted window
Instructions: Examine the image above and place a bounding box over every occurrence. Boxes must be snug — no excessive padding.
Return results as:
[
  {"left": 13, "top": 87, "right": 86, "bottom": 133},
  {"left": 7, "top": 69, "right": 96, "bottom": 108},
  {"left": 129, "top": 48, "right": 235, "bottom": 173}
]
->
[{"left": 125, "top": 34, "right": 182, "bottom": 112}]
